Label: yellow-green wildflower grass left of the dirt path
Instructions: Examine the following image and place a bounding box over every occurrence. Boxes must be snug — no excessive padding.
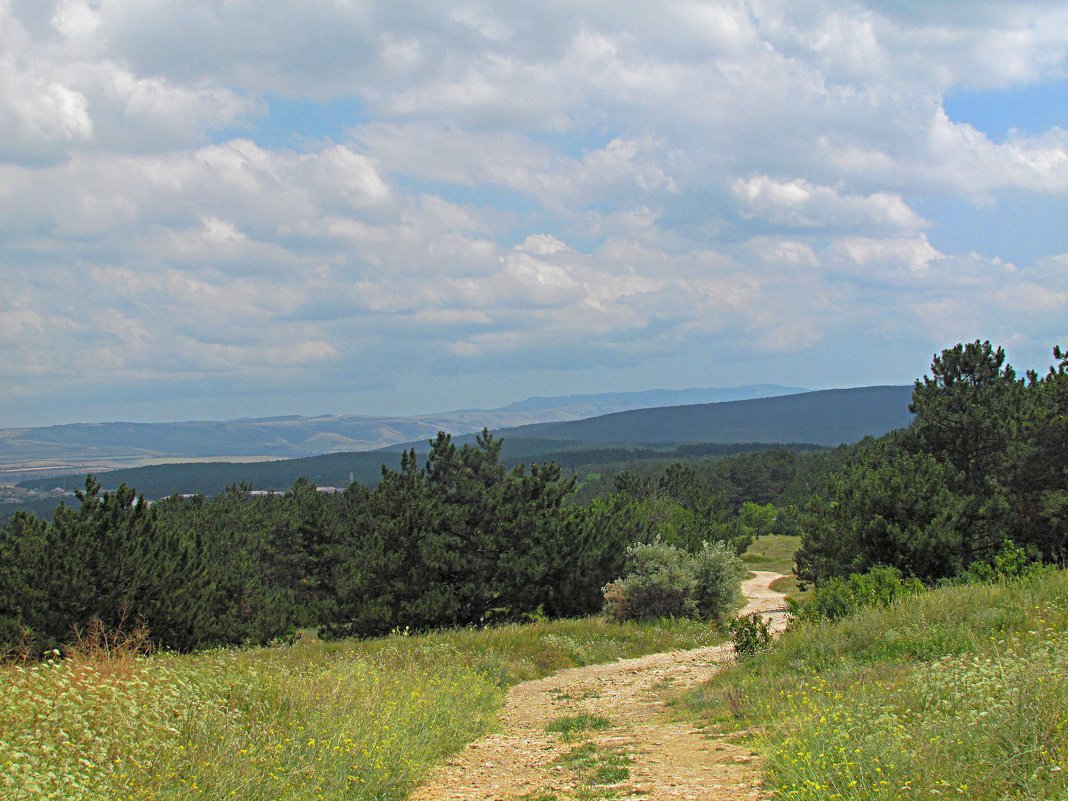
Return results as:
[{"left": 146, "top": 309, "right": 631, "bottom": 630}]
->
[{"left": 0, "top": 618, "right": 721, "bottom": 801}]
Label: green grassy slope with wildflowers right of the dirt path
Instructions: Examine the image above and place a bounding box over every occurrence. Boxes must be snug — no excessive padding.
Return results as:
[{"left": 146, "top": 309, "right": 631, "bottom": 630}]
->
[{"left": 684, "top": 571, "right": 1068, "bottom": 801}]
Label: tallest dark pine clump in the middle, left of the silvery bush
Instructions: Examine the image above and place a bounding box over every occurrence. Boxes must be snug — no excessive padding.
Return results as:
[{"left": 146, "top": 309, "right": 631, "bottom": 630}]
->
[{"left": 325, "top": 433, "right": 625, "bottom": 637}]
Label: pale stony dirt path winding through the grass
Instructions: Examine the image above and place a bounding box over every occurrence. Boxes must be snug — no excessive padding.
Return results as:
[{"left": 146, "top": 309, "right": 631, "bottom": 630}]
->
[{"left": 412, "top": 571, "right": 785, "bottom": 801}]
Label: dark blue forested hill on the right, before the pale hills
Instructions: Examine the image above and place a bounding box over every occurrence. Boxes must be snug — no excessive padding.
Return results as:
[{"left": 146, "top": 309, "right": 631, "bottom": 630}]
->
[{"left": 489, "top": 387, "right": 912, "bottom": 446}]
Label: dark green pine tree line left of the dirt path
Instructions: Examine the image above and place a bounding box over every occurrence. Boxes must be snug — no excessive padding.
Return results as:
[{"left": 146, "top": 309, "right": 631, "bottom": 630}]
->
[{"left": 0, "top": 431, "right": 781, "bottom": 651}]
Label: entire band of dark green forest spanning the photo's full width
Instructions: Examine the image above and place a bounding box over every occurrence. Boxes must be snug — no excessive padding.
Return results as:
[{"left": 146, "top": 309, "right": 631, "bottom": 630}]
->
[{"left": 0, "top": 342, "right": 1068, "bottom": 654}]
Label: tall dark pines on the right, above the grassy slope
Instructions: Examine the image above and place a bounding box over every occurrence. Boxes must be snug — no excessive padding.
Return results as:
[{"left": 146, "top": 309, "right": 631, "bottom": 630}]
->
[{"left": 797, "top": 342, "right": 1068, "bottom": 583}]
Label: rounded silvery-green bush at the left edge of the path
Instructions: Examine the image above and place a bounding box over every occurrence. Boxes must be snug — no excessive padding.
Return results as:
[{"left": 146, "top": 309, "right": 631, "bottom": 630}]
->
[{"left": 604, "top": 541, "right": 745, "bottom": 621}]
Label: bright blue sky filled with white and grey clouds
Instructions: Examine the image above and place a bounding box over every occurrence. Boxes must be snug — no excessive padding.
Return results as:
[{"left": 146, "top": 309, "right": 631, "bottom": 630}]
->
[{"left": 0, "top": 0, "right": 1068, "bottom": 427}]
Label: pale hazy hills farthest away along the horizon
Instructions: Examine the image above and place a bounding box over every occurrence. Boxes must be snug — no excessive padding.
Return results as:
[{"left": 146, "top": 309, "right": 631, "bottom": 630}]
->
[{"left": 0, "top": 384, "right": 802, "bottom": 481}]
